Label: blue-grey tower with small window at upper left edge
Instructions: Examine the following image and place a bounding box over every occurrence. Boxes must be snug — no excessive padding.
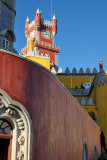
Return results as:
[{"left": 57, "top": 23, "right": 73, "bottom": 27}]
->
[{"left": 0, "top": 0, "right": 16, "bottom": 52}]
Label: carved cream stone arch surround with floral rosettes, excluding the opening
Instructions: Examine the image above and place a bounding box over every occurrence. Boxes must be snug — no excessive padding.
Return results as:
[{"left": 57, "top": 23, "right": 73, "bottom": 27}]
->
[{"left": 0, "top": 89, "right": 33, "bottom": 160}]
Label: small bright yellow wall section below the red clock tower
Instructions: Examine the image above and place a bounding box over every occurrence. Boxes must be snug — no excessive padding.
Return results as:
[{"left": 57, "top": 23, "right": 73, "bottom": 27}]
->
[{"left": 26, "top": 56, "right": 50, "bottom": 70}]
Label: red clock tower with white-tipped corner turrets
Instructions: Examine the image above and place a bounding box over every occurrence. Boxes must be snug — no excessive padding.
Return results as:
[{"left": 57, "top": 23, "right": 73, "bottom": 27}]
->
[{"left": 21, "top": 9, "right": 60, "bottom": 70}]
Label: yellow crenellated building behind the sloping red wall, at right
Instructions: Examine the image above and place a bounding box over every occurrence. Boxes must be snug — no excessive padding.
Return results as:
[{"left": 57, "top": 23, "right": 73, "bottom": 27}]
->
[{"left": 57, "top": 68, "right": 107, "bottom": 148}]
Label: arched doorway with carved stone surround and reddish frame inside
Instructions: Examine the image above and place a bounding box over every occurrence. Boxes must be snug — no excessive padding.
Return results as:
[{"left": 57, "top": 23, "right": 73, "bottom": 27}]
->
[{"left": 0, "top": 89, "right": 33, "bottom": 160}]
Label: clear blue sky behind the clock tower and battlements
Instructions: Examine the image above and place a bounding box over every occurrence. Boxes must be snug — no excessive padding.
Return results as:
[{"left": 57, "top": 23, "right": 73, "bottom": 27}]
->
[{"left": 14, "top": 0, "right": 107, "bottom": 71}]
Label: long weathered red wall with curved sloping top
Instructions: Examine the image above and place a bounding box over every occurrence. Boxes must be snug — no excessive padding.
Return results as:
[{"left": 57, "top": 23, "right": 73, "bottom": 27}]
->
[{"left": 0, "top": 52, "right": 100, "bottom": 160}]
